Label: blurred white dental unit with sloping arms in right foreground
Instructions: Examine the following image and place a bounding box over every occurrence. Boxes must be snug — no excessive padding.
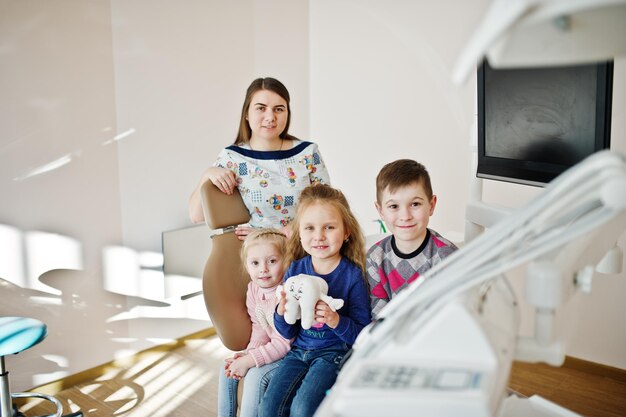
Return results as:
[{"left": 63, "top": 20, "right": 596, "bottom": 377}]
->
[{"left": 318, "top": 151, "right": 626, "bottom": 416}]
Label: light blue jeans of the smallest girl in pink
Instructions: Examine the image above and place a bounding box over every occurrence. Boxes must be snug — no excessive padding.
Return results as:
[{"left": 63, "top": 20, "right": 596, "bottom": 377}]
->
[{"left": 217, "top": 361, "right": 280, "bottom": 417}]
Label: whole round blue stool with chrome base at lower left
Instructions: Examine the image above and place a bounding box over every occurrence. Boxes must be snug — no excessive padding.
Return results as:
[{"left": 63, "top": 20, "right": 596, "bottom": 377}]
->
[{"left": 0, "top": 317, "right": 63, "bottom": 417}]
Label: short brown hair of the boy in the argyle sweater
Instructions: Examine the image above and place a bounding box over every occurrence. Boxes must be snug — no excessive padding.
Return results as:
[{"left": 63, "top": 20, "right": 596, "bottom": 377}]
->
[{"left": 376, "top": 159, "right": 433, "bottom": 204}]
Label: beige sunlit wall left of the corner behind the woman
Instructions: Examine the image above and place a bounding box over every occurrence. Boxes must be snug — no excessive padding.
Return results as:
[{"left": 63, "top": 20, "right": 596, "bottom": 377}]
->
[{"left": 0, "top": 0, "right": 309, "bottom": 390}]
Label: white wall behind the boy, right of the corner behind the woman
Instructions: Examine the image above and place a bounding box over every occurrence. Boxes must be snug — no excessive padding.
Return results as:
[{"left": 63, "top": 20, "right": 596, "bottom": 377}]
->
[{"left": 310, "top": 0, "right": 626, "bottom": 368}]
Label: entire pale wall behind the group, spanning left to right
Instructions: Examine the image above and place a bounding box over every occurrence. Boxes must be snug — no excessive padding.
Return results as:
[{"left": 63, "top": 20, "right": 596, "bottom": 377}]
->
[{"left": 0, "top": 0, "right": 626, "bottom": 389}]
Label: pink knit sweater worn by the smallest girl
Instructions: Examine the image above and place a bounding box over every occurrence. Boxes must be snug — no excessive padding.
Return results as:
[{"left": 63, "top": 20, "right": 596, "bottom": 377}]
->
[{"left": 246, "top": 282, "right": 291, "bottom": 367}]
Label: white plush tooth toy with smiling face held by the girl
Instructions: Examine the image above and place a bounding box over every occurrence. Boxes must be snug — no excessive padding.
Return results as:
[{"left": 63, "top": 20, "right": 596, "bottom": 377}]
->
[{"left": 276, "top": 274, "right": 343, "bottom": 329}]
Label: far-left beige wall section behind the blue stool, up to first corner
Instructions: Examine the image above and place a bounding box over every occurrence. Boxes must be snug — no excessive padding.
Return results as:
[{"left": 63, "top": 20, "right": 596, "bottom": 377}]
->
[{"left": 0, "top": 1, "right": 127, "bottom": 389}]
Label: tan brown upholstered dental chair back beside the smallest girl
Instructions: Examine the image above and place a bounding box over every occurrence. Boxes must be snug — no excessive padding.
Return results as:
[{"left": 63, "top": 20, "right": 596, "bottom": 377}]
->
[{"left": 201, "top": 181, "right": 252, "bottom": 350}]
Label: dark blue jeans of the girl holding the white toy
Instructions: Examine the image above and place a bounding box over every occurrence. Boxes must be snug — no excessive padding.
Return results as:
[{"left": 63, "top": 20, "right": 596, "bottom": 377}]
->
[{"left": 259, "top": 343, "right": 348, "bottom": 417}]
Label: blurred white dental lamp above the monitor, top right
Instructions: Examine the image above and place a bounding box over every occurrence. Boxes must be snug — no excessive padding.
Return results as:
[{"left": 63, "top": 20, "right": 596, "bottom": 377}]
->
[{"left": 452, "top": 0, "right": 626, "bottom": 84}]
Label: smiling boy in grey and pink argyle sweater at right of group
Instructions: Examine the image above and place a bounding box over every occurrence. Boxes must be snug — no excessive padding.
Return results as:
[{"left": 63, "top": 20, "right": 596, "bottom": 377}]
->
[{"left": 366, "top": 159, "right": 457, "bottom": 317}]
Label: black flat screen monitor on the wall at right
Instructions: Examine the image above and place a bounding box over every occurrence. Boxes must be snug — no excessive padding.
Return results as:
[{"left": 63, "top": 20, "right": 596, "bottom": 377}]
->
[{"left": 476, "top": 60, "right": 613, "bottom": 186}]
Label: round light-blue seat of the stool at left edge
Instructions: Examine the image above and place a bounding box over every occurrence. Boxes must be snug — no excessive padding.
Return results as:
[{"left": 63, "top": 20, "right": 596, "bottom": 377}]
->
[{"left": 0, "top": 317, "right": 48, "bottom": 356}]
